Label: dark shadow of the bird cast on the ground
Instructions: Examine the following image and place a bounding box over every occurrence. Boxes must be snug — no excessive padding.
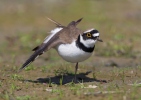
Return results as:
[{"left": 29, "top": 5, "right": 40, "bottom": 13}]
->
[{"left": 22, "top": 71, "right": 107, "bottom": 85}]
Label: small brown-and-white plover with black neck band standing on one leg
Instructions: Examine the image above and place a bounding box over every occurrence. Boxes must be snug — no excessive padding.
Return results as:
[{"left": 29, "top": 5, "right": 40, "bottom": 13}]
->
[{"left": 19, "top": 17, "right": 103, "bottom": 82}]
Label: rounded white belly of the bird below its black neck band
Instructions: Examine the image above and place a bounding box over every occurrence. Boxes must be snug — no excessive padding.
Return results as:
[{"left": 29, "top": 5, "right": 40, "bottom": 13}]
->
[{"left": 56, "top": 42, "right": 92, "bottom": 63}]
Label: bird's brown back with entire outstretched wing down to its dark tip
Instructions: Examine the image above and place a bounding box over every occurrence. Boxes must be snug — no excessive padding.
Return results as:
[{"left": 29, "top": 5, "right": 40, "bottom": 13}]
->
[{"left": 20, "top": 19, "right": 82, "bottom": 70}]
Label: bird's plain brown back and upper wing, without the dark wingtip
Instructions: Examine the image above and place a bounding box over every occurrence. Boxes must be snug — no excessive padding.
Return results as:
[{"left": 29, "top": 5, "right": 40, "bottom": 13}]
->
[{"left": 46, "top": 18, "right": 82, "bottom": 50}]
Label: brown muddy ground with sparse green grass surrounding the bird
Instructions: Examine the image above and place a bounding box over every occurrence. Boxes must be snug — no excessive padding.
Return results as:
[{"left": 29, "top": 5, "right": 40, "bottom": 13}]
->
[{"left": 0, "top": 0, "right": 141, "bottom": 100}]
